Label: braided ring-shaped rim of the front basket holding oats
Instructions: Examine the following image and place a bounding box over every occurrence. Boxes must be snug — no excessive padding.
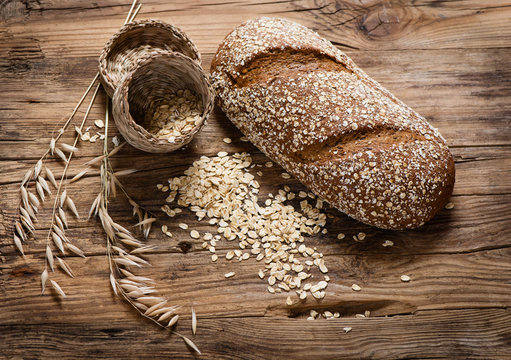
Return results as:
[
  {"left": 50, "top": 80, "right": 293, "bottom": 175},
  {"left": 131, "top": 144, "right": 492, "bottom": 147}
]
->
[{"left": 113, "top": 50, "right": 215, "bottom": 150}]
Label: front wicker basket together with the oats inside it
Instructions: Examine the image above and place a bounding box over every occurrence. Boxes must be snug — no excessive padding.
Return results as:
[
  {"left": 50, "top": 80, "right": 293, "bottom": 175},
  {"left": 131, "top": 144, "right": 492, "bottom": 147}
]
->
[{"left": 112, "top": 51, "right": 214, "bottom": 153}]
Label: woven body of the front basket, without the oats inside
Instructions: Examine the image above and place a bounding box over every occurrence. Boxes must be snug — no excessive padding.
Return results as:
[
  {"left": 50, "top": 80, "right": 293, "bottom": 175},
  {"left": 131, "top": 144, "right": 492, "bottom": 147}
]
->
[{"left": 112, "top": 50, "right": 214, "bottom": 153}]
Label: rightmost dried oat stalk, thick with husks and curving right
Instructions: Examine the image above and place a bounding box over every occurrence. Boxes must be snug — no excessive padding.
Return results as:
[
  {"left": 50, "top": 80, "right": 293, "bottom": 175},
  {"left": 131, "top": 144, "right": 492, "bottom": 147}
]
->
[{"left": 94, "top": 96, "right": 200, "bottom": 354}]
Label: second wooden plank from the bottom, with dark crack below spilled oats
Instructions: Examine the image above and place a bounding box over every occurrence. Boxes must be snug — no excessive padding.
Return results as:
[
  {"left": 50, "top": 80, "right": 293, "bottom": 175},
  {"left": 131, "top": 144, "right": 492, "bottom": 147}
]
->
[{"left": 0, "top": 248, "right": 511, "bottom": 325}]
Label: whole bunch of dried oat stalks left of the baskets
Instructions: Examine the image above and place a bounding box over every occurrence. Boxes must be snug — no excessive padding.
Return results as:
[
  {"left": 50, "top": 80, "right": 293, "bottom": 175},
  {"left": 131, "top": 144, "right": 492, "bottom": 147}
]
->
[{"left": 13, "top": 0, "right": 200, "bottom": 354}]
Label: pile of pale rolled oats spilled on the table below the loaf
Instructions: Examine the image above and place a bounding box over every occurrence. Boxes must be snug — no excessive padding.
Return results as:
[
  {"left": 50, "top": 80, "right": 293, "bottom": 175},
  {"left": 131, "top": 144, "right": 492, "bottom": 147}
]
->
[{"left": 158, "top": 152, "right": 330, "bottom": 305}]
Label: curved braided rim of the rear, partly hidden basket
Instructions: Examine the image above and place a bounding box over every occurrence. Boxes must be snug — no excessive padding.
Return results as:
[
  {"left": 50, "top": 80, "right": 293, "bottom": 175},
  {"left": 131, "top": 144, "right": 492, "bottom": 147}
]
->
[{"left": 98, "top": 19, "right": 202, "bottom": 97}]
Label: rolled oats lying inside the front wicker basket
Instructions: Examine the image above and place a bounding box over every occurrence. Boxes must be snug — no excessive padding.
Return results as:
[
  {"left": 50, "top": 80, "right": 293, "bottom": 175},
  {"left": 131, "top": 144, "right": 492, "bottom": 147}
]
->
[{"left": 144, "top": 89, "right": 203, "bottom": 143}]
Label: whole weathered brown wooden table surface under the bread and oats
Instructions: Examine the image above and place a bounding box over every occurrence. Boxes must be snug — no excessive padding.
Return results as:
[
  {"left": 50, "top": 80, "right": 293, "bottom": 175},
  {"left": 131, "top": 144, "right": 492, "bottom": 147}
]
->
[{"left": 0, "top": 0, "right": 511, "bottom": 359}]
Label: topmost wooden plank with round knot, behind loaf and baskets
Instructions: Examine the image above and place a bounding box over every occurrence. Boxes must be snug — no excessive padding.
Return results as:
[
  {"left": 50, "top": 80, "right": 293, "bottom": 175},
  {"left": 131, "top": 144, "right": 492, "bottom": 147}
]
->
[{"left": 0, "top": 0, "right": 511, "bottom": 56}]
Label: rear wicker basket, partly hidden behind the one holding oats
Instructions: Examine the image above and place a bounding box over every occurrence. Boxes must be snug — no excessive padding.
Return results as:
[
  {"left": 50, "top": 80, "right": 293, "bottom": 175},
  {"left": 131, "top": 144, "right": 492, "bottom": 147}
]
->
[{"left": 99, "top": 20, "right": 201, "bottom": 97}]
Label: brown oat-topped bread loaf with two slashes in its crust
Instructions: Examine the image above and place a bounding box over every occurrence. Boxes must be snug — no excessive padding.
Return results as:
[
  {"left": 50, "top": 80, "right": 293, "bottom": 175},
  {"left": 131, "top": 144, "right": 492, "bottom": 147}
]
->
[{"left": 211, "top": 18, "right": 454, "bottom": 229}]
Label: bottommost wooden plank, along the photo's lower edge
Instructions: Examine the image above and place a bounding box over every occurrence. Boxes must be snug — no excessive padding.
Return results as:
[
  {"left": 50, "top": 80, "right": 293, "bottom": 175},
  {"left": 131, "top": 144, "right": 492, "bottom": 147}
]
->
[{"left": 0, "top": 308, "right": 511, "bottom": 360}]
